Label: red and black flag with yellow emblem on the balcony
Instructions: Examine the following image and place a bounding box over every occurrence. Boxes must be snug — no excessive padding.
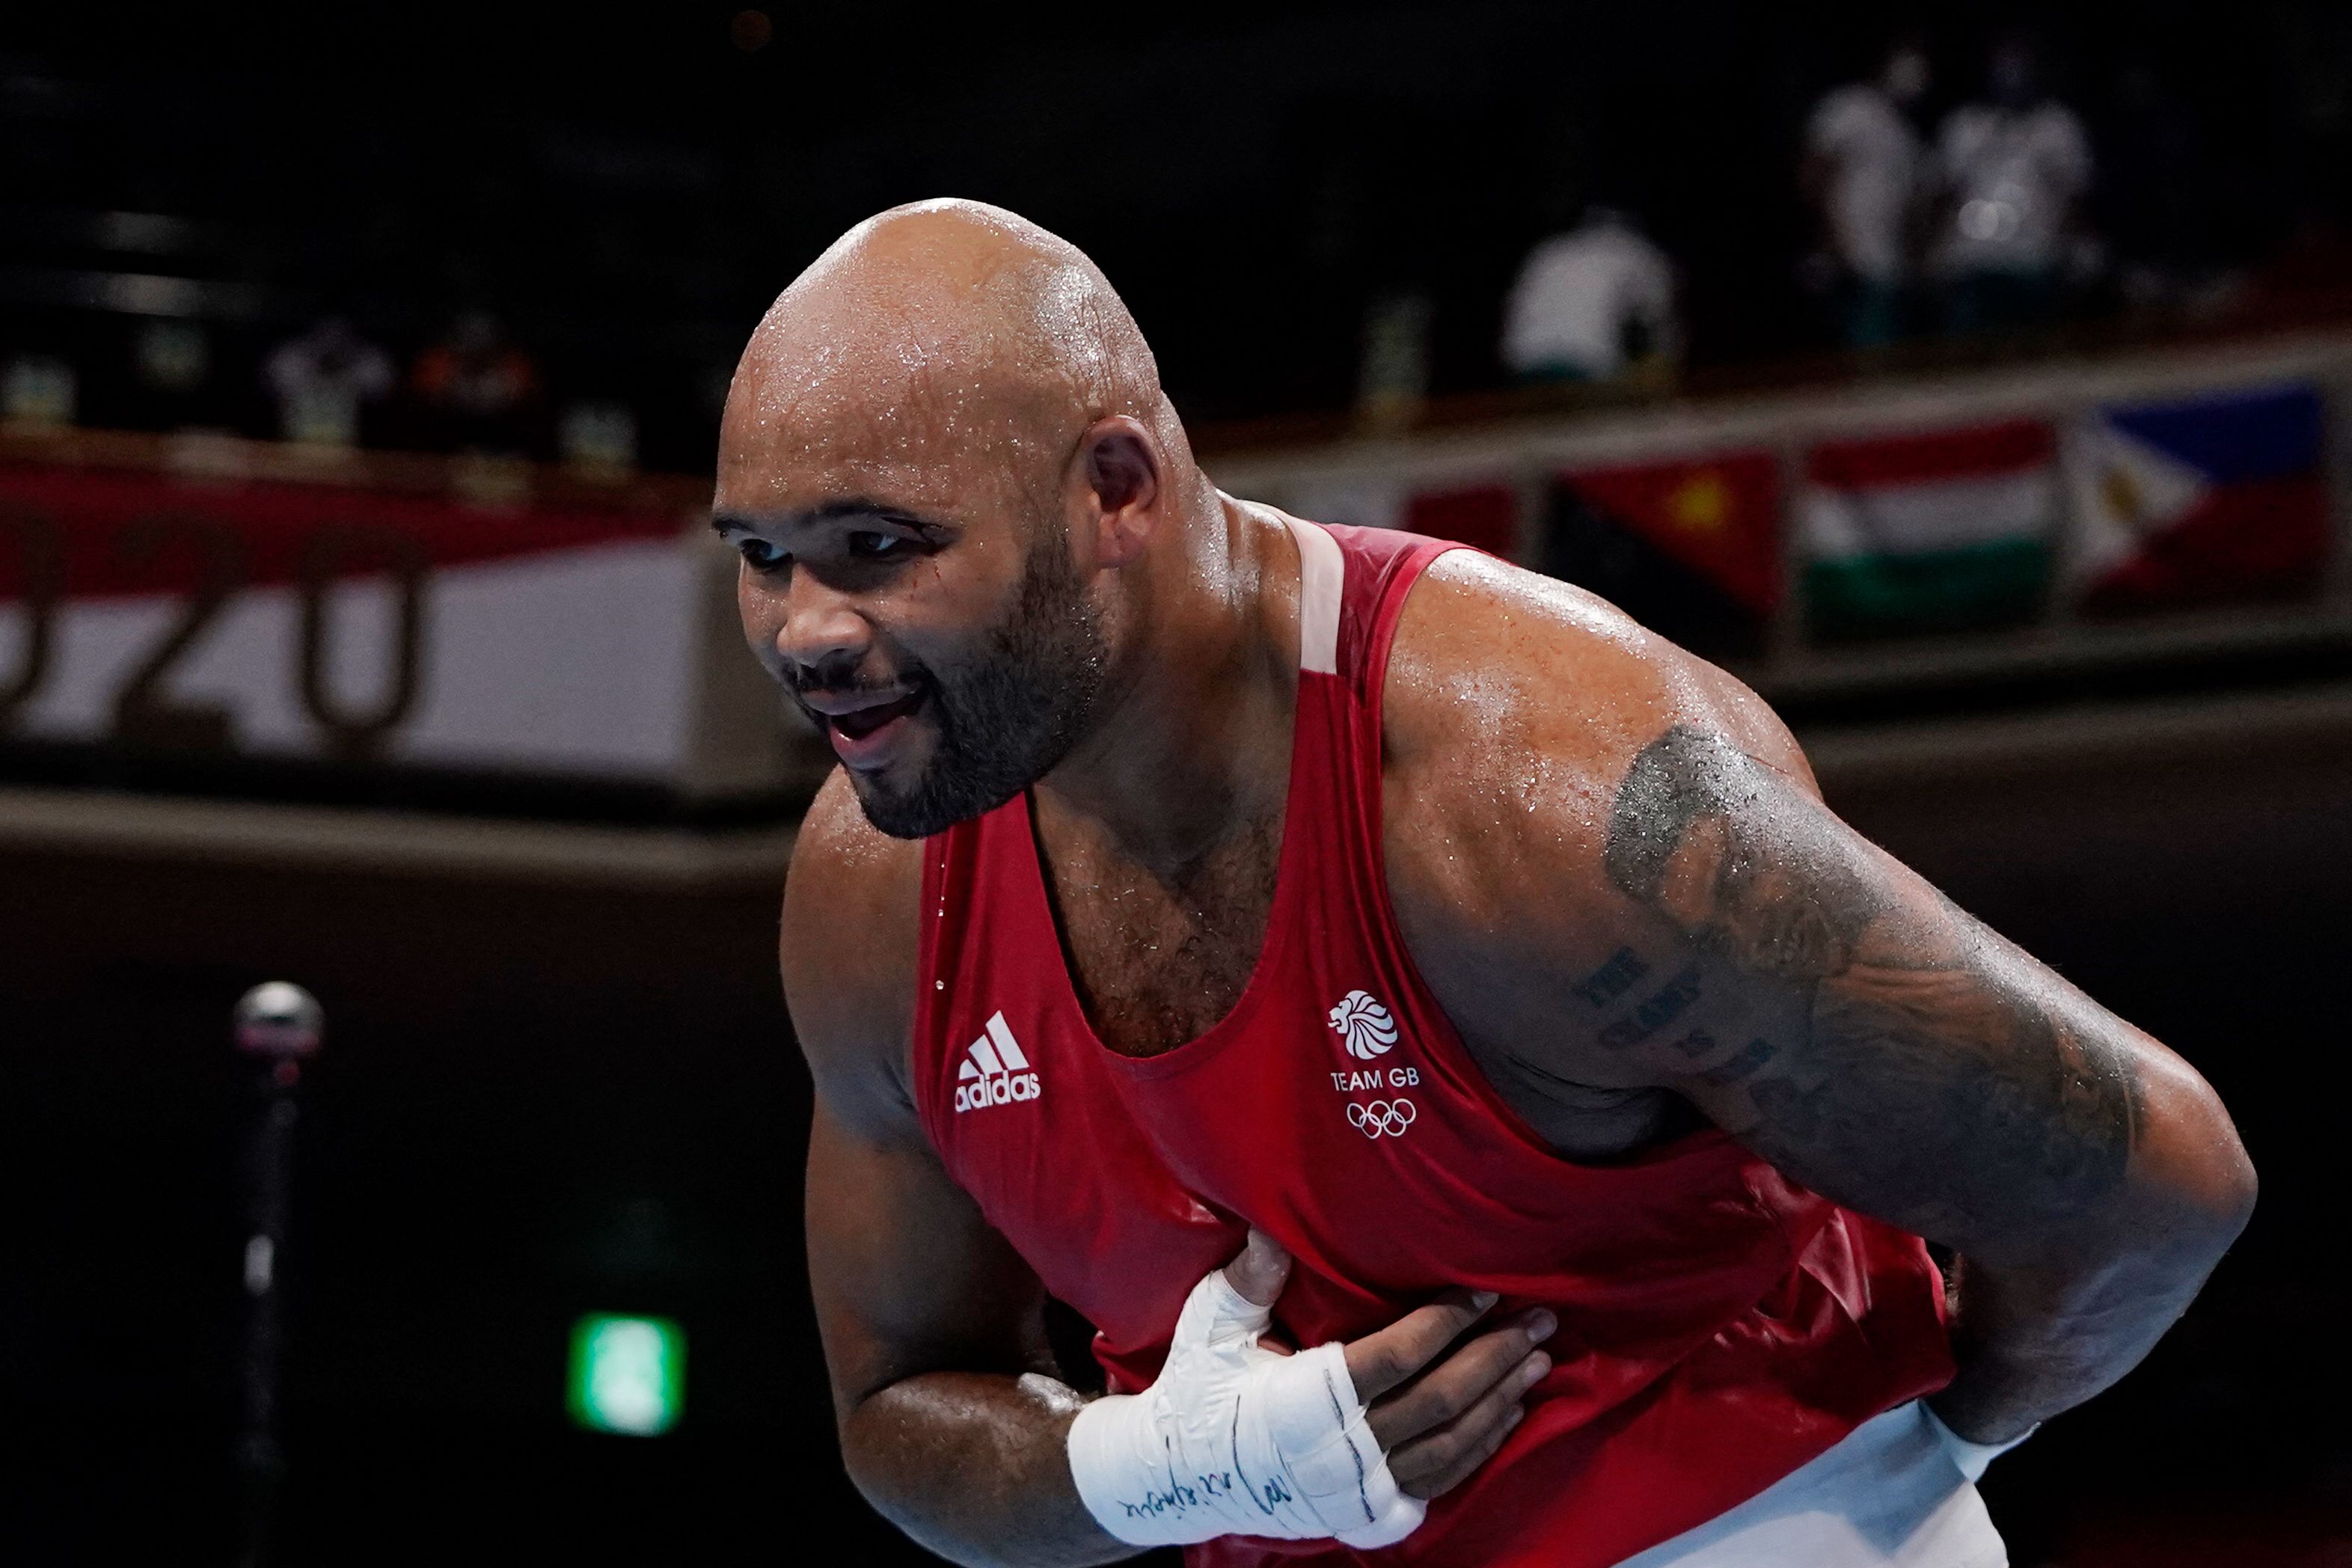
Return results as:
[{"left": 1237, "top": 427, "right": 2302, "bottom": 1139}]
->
[{"left": 1543, "top": 451, "right": 1780, "bottom": 658}]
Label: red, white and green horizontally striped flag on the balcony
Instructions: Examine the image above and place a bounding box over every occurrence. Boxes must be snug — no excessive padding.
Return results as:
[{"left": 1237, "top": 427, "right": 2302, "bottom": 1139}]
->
[{"left": 1797, "top": 420, "right": 2058, "bottom": 640}]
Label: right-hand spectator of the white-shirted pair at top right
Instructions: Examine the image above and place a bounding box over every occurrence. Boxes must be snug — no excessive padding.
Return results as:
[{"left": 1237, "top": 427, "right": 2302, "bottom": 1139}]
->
[{"left": 1936, "top": 101, "right": 2091, "bottom": 275}]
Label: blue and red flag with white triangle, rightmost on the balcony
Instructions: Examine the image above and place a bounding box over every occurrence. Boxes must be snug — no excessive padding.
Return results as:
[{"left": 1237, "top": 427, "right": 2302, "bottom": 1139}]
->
[{"left": 2068, "top": 385, "right": 2329, "bottom": 613}]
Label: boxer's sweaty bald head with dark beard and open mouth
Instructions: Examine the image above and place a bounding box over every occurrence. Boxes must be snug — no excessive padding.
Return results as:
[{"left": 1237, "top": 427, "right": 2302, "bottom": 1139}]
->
[{"left": 713, "top": 202, "right": 1223, "bottom": 837}]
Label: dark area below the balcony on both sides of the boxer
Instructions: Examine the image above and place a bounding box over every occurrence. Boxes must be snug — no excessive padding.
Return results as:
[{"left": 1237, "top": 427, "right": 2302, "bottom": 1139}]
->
[{"left": 0, "top": 726, "right": 2352, "bottom": 1566}]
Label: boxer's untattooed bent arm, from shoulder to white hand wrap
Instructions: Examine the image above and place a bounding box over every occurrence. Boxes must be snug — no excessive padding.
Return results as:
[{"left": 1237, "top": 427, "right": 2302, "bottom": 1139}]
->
[{"left": 781, "top": 776, "right": 1133, "bottom": 1564}]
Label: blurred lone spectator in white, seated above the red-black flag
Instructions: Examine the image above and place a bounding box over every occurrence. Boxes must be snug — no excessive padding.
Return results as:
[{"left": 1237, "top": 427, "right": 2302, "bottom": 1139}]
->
[{"left": 1503, "top": 207, "right": 1682, "bottom": 381}]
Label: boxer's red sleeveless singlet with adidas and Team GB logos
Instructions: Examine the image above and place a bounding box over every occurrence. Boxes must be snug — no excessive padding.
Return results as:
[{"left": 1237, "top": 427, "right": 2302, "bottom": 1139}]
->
[{"left": 913, "top": 522, "right": 1953, "bottom": 1568}]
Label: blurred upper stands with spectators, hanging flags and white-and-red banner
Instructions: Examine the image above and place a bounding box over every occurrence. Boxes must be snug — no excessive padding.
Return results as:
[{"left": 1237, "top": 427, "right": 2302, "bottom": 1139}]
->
[{"left": 0, "top": 0, "right": 2352, "bottom": 815}]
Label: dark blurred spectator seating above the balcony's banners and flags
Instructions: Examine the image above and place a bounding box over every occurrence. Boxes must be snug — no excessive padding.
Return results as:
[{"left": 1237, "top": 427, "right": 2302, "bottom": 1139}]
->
[{"left": 0, "top": 0, "right": 2352, "bottom": 473}]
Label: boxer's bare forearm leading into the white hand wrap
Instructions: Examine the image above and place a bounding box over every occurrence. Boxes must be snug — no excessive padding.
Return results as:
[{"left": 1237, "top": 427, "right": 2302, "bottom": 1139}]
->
[{"left": 842, "top": 1373, "right": 1136, "bottom": 1568}]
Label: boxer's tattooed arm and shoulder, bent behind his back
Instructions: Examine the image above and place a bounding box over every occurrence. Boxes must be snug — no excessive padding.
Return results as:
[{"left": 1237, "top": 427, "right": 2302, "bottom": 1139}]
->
[{"left": 1390, "top": 554, "right": 2253, "bottom": 1441}]
